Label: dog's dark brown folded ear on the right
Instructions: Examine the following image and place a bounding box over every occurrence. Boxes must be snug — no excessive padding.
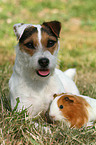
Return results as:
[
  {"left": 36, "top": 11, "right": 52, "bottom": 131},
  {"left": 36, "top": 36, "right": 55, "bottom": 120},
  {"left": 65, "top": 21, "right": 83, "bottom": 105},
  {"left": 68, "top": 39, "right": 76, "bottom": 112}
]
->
[{"left": 42, "top": 21, "right": 61, "bottom": 38}]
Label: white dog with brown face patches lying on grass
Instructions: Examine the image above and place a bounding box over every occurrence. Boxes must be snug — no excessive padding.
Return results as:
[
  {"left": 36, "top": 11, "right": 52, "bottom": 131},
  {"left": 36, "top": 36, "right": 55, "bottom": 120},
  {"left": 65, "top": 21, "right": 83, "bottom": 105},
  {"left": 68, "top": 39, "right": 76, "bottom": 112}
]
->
[{"left": 9, "top": 21, "right": 79, "bottom": 116}]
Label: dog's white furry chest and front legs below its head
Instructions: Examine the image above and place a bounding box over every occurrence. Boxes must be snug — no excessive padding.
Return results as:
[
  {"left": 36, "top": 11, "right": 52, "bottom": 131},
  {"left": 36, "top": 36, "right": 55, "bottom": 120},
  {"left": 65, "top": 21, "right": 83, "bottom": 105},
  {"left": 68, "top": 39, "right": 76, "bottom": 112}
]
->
[{"left": 10, "top": 72, "right": 64, "bottom": 115}]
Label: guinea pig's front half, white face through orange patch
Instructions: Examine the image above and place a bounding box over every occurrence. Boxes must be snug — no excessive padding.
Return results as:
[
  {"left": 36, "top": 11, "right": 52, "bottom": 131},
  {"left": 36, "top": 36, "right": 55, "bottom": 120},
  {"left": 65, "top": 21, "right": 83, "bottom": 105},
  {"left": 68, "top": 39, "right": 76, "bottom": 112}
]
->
[{"left": 49, "top": 93, "right": 88, "bottom": 128}]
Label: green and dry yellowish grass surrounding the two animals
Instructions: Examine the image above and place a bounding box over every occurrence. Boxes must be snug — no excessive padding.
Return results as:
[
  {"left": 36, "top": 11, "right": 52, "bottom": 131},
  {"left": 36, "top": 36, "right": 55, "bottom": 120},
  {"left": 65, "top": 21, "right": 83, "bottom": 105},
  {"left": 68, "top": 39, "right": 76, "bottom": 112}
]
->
[{"left": 0, "top": 0, "right": 96, "bottom": 145}]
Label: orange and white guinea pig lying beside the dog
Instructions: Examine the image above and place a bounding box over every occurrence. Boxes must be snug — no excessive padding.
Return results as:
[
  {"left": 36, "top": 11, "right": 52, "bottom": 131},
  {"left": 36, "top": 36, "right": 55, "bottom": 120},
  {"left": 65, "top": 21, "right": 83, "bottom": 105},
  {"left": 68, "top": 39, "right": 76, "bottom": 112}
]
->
[{"left": 49, "top": 93, "right": 96, "bottom": 128}]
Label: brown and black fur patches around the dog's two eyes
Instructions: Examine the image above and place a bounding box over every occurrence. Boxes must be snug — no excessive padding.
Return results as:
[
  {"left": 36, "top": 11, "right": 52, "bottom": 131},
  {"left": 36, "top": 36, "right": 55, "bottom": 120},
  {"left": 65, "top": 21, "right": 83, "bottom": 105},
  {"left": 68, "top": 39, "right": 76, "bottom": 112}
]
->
[{"left": 19, "top": 25, "right": 58, "bottom": 56}]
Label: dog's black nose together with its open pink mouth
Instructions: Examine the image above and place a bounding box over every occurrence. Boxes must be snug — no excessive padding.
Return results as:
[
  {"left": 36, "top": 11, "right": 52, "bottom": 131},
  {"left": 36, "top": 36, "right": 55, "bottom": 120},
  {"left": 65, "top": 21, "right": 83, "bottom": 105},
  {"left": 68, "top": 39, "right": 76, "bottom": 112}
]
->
[{"left": 37, "top": 57, "right": 50, "bottom": 77}]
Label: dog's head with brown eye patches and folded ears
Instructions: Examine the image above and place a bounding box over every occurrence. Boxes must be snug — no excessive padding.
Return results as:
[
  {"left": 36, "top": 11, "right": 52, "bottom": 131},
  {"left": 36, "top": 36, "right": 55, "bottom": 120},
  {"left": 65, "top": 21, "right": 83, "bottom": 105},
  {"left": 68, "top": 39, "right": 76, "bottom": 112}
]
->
[{"left": 14, "top": 21, "right": 61, "bottom": 78}]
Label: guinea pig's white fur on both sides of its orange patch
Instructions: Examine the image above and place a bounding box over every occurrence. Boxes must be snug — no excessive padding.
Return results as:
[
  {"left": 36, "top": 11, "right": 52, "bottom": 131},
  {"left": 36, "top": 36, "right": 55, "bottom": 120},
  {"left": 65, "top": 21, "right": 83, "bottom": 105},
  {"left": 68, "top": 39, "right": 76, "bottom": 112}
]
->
[{"left": 49, "top": 95, "right": 96, "bottom": 127}]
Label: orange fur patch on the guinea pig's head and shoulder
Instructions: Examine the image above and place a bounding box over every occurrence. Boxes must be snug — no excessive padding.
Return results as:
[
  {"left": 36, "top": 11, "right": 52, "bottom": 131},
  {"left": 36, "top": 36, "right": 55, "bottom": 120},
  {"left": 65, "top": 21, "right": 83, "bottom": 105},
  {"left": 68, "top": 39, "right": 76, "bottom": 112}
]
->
[{"left": 57, "top": 94, "right": 89, "bottom": 128}]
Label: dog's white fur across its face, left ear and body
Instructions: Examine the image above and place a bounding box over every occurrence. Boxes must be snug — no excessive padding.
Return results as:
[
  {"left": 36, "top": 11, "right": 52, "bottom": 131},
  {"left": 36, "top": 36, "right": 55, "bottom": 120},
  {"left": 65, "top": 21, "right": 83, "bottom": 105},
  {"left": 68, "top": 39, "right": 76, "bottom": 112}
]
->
[{"left": 9, "top": 24, "right": 79, "bottom": 116}]
